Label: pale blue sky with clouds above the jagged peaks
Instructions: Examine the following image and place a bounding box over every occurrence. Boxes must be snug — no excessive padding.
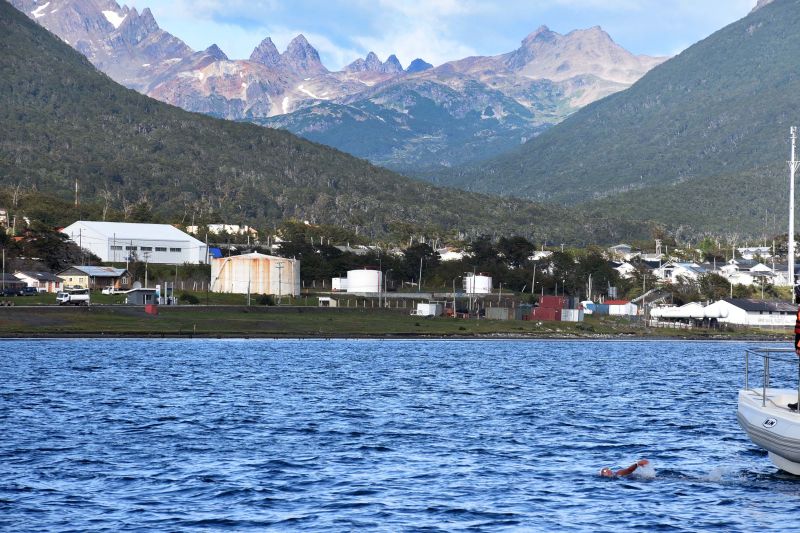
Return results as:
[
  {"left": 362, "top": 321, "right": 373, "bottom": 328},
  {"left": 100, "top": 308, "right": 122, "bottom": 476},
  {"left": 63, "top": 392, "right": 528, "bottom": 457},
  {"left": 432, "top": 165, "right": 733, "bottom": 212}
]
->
[{"left": 128, "top": 0, "right": 756, "bottom": 70}]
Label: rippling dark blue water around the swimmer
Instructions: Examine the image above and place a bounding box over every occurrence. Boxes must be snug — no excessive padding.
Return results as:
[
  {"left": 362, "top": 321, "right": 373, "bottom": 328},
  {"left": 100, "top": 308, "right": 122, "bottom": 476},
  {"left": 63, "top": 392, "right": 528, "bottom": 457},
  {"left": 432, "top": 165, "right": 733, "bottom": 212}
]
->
[{"left": 0, "top": 340, "right": 800, "bottom": 531}]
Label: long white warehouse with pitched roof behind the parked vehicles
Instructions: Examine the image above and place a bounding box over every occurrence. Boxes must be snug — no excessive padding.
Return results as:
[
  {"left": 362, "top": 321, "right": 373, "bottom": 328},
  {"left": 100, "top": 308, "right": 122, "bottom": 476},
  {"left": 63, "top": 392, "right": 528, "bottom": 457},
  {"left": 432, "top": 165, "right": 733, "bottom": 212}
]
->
[{"left": 61, "top": 220, "right": 206, "bottom": 265}]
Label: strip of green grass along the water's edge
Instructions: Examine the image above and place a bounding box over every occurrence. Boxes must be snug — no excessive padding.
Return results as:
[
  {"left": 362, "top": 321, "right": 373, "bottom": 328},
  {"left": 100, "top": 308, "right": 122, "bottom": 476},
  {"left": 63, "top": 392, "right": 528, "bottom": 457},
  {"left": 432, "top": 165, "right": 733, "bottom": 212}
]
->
[{"left": 0, "top": 305, "right": 788, "bottom": 339}]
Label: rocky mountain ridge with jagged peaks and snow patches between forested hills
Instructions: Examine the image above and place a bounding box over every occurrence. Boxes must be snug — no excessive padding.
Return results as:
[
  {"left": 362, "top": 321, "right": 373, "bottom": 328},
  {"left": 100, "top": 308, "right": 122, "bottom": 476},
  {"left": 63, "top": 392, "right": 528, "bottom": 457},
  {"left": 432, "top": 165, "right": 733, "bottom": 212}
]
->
[{"left": 12, "top": 0, "right": 664, "bottom": 169}]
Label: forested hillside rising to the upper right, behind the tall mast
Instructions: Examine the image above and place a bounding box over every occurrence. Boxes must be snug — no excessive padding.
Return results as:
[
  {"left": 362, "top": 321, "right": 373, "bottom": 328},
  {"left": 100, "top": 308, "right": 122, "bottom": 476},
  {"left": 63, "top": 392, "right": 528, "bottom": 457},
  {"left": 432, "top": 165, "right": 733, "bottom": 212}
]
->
[{"left": 439, "top": 0, "right": 800, "bottom": 235}]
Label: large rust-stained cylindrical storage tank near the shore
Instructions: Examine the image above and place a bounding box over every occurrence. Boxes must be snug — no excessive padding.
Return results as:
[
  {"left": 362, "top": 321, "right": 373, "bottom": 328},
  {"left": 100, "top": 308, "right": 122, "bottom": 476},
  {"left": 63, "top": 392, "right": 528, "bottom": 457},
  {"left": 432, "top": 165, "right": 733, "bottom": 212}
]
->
[{"left": 209, "top": 253, "right": 300, "bottom": 296}]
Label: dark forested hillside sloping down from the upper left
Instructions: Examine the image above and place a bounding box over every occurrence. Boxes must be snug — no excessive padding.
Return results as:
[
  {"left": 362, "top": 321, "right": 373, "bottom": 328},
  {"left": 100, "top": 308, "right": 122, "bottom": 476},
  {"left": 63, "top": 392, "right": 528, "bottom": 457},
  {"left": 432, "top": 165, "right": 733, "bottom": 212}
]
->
[{"left": 0, "top": 2, "right": 647, "bottom": 242}]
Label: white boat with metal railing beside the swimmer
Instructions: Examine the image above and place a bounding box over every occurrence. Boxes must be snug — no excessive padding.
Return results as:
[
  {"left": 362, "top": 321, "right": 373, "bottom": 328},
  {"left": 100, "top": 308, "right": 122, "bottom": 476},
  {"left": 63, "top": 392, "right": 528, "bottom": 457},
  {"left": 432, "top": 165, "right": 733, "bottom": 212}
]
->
[{"left": 736, "top": 348, "right": 800, "bottom": 476}]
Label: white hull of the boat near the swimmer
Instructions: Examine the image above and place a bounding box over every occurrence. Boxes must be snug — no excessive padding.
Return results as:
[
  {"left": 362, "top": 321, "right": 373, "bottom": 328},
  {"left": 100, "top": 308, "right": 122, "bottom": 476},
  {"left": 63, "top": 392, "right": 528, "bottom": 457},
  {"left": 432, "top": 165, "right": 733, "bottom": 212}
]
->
[{"left": 736, "top": 389, "right": 800, "bottom": 475}]
